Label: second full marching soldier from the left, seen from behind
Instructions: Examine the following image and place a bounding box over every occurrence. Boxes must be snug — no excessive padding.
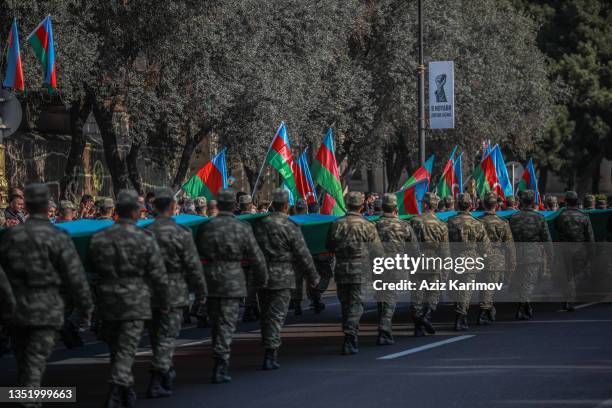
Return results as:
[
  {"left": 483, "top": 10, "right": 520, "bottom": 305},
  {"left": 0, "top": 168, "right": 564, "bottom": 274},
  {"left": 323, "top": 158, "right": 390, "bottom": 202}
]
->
[{"left": 89, "top": 190, "right": 170, "bottom": 408}]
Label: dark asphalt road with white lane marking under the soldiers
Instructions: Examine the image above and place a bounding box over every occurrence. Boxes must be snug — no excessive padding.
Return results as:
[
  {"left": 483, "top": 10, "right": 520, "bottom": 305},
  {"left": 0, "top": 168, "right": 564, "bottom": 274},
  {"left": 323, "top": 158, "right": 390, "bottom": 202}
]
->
[{"left": 0, "top": 297, "right": 612, "bottom": 408}]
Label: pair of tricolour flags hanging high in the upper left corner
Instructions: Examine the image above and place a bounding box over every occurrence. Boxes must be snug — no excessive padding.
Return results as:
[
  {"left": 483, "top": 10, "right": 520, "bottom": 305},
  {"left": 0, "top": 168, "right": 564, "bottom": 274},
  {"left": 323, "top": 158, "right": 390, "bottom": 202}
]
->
[{"left": 2, "top": 16, "right": 57, "bottom": 91}]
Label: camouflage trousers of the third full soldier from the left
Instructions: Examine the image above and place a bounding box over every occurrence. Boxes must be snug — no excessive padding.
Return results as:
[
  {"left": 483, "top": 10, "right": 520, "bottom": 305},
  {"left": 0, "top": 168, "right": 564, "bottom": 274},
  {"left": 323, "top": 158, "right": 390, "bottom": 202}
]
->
[{"left": 148, "top": 308, "right": 183, "bottom": 373}]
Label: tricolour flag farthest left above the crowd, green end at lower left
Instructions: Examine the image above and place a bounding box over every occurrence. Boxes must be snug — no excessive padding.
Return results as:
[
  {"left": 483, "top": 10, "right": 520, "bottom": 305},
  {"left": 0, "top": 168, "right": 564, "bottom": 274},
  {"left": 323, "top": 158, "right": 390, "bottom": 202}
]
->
[{"left": 181, "top": 148, "right": 227, "bottom": 200}]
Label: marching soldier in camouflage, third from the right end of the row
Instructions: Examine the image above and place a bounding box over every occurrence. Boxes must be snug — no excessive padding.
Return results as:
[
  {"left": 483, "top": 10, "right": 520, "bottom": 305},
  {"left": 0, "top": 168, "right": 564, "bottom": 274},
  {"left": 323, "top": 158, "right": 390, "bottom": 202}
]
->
[{"left": 478, "top": 191, "right": 516, "bottom": 325}]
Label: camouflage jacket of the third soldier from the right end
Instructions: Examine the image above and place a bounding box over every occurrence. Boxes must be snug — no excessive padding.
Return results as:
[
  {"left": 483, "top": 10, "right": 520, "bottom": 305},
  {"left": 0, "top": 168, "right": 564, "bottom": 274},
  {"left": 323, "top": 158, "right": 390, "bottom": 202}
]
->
[{"left": 480, "top": 212, "right": 516, "bottom": 273}]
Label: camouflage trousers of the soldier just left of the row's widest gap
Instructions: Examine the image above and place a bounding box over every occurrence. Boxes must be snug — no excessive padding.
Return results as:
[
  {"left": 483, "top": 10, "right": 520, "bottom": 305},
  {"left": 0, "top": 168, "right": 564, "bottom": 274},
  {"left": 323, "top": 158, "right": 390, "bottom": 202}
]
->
[{"left": 258, "top": 289, "right": 291, "bottom": 349}]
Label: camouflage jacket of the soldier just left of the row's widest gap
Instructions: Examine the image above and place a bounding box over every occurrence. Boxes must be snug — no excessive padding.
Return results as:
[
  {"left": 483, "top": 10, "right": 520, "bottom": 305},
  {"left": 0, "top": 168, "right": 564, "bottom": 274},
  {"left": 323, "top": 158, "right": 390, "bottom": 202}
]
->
[{"left": 254, "top": 212, "right": 319, "bottom": 289}]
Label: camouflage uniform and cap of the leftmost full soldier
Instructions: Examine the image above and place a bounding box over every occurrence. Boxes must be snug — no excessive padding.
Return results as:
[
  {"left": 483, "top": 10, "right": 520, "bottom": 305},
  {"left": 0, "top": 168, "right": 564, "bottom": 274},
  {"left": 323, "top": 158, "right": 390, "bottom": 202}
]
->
[{"left": 0, "top": 184, "right": 92, "bottom": 406}]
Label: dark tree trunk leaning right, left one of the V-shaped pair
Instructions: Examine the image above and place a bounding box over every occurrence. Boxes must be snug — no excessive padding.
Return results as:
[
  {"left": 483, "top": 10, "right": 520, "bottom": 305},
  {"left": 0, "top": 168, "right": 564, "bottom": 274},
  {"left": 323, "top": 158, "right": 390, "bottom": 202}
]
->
[{"left": 60, "top": 97, "right": 91, "bottom": 202}]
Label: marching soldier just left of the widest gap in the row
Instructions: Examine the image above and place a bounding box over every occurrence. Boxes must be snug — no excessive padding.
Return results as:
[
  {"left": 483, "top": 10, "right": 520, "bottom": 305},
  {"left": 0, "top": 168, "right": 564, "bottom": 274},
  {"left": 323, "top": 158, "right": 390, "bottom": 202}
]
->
[{"left": 254, "top": 188, "right": 320, "bottom": 370}]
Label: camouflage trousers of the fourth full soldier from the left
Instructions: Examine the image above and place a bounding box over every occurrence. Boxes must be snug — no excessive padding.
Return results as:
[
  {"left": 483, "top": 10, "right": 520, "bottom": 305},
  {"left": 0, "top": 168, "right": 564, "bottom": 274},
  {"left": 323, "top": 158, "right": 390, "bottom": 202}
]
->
[{"left": 207, "top": 298, "right": 240, "bottom": 360}]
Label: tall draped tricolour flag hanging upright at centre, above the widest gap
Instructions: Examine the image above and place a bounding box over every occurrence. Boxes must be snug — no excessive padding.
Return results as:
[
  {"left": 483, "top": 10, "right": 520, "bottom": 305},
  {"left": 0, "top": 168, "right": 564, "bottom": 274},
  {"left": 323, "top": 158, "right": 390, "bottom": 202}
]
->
[{"left": 312, "top": 128, "right": 346, "bottom": 215}]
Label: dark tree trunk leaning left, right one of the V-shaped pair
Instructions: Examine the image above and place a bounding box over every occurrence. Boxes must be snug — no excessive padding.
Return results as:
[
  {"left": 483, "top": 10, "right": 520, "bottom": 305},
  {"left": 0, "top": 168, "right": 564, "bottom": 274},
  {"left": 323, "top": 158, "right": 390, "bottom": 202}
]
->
[{"left": 93, "top": 101, "right": 130, "bottom": 194}]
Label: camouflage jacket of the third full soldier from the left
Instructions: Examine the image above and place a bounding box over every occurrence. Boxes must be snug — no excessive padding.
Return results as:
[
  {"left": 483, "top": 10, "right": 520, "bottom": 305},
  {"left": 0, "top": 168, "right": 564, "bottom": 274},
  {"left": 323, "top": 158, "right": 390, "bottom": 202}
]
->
[{"left": 146, "top": 216, "right": 206, "bottom": 307}]
